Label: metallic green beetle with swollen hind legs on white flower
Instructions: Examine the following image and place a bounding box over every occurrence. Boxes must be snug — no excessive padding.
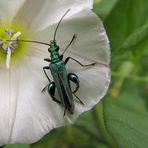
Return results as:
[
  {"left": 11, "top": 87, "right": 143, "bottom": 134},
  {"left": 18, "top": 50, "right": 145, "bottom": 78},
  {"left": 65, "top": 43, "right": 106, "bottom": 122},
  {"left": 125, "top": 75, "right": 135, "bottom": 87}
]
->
[{"left": 43, "top": 36, "right": 83, "bottom": 115}]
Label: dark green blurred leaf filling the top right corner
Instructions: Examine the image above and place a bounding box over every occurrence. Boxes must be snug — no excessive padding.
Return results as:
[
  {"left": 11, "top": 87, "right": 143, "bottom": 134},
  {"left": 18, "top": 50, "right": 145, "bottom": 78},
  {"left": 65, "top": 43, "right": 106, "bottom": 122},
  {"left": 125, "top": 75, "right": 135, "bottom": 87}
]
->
[{"left": 105, "top": 0, "right": 148, "bottom": 52}]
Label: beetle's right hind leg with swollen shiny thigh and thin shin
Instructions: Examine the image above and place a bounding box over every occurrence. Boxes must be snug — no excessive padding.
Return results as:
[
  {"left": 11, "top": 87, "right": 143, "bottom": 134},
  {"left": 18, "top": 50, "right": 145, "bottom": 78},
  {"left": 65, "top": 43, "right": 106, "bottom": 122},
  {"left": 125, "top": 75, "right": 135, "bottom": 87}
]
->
[{"left": 68, "top": 73, "right": 84, "bottom": 105}]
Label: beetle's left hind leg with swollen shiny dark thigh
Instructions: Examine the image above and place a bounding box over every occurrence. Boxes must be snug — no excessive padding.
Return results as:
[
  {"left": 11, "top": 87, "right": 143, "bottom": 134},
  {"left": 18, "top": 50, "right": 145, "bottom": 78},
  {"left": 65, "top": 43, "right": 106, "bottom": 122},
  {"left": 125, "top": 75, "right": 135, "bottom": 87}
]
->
[{"left": 48, "top": 82, "right": 61, "bottom": 104}]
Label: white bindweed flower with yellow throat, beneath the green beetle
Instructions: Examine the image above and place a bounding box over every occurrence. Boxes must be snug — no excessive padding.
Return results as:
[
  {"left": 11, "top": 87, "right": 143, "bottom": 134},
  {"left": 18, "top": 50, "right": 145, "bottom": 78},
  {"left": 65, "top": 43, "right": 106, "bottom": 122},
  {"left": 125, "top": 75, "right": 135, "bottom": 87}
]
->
[{"left": 0, "top": 0, "right": 110, "bottom": 145}]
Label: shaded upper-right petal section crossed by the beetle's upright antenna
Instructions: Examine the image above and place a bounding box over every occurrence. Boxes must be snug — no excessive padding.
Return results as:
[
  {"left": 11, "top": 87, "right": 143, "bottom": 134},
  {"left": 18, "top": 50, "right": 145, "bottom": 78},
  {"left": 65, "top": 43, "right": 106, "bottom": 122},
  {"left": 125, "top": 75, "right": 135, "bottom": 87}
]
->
[{"left": 35, "top": 9, "right": 110, "bottom": 65}]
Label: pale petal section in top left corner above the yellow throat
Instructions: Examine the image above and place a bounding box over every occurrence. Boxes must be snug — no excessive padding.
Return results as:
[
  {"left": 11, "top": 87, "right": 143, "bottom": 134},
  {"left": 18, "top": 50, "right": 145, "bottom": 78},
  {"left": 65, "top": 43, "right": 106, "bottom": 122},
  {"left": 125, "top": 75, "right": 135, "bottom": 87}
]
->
[{"left": 0, "top": 0, "right": 25, "bottom": 23}]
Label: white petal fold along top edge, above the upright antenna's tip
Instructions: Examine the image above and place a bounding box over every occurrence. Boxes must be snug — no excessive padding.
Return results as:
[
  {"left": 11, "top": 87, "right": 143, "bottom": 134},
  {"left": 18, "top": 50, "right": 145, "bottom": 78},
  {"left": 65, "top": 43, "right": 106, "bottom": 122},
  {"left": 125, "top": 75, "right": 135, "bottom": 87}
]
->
[{"left": 15, "top": 0, "right": 93, "bottom": 29}]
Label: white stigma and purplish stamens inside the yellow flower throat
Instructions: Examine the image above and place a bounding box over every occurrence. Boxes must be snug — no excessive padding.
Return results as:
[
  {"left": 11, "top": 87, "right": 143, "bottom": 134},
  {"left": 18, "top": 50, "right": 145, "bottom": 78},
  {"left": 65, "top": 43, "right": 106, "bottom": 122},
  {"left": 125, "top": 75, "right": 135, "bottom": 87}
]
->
[{"left": 0, "top": 29, "right": 21, "bottom": 68}]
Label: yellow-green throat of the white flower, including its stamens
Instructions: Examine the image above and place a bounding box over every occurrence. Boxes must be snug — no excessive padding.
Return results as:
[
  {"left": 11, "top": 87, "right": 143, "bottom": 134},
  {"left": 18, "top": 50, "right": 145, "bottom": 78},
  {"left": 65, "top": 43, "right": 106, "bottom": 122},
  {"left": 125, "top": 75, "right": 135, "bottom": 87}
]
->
[{"left": 0, "top": 21, "right": 34, "bottom": 69}]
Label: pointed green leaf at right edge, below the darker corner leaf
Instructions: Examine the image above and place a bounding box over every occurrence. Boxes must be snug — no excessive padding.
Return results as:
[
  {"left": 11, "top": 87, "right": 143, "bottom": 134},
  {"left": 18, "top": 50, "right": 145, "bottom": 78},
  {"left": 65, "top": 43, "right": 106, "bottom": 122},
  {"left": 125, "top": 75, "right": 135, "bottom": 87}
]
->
[{"left": 112, "top": 24, "right": 148, "bottom": 66}]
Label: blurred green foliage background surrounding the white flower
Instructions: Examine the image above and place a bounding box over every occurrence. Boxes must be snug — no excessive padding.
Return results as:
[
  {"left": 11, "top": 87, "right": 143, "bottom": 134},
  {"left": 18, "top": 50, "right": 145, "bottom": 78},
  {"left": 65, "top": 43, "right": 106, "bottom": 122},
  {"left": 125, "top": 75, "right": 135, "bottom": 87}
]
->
[{"left": 2, "top": 0, "right": 148, "bottom": 148}]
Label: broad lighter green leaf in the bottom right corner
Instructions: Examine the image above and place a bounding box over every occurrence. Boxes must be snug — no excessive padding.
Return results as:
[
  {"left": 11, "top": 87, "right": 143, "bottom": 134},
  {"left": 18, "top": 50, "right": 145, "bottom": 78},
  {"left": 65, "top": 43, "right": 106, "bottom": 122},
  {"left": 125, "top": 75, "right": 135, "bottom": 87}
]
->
[{"left": 104, "top": 81, "right": 148, "bottom": 148}]
